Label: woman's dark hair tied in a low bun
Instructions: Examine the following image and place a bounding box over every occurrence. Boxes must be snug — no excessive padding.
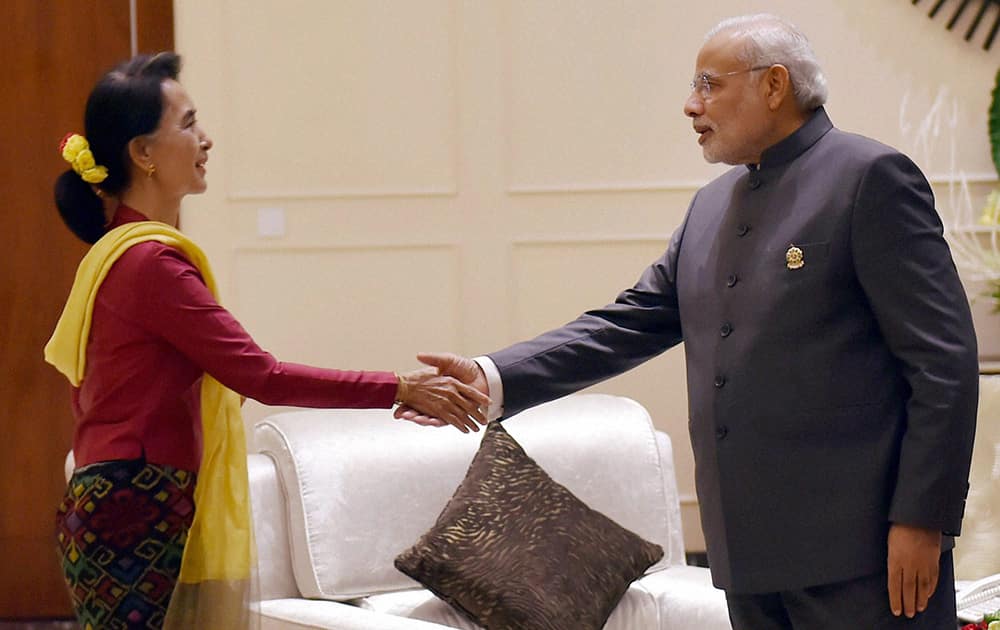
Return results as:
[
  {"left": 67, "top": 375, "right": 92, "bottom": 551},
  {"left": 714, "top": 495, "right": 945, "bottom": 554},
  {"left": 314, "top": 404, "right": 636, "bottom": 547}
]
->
[{"left": 55, "top": 52, "right": 181, "bottom": 243}]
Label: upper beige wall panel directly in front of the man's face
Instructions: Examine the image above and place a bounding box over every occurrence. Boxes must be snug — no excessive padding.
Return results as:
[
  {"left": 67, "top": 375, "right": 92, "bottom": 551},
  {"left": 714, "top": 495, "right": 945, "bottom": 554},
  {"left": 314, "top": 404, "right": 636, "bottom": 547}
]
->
[{"left": 503, "top": 0, "right": 716, "bottom": 192}]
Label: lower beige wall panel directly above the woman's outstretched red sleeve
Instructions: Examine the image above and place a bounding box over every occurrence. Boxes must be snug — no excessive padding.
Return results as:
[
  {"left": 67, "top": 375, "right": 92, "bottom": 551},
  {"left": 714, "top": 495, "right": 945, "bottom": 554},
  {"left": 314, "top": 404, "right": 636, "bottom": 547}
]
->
[{"left": 233, "top": 245, "right": 462, "bottom": 370}]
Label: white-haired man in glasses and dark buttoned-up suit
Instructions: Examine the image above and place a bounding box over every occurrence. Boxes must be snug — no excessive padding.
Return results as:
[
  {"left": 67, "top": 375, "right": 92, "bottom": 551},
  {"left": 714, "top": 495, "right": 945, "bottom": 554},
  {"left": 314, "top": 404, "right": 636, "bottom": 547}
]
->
[{"left": 397, "top": 15, "right": 978, "bottom": 630}]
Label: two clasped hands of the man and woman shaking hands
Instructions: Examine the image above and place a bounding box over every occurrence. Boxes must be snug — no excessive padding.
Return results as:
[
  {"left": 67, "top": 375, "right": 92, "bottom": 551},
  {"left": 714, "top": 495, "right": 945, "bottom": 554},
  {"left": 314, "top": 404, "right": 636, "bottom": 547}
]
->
[{"left": 393, "top": 353, "right": 490, "bottom": 433}]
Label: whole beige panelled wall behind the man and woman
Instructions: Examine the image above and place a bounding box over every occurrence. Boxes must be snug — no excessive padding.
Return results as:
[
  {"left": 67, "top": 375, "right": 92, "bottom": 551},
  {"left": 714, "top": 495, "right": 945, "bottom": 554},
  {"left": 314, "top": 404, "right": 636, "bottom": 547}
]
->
[{"left": 176, "top": 0, "right": 1000, "bottom": 549}]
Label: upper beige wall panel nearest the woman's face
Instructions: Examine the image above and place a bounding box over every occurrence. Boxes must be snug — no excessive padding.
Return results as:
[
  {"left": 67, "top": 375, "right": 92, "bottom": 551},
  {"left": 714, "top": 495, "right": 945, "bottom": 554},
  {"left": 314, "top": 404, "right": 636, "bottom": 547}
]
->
[{"left": 224, "top": 0, "right": 457, "bottom": 199}]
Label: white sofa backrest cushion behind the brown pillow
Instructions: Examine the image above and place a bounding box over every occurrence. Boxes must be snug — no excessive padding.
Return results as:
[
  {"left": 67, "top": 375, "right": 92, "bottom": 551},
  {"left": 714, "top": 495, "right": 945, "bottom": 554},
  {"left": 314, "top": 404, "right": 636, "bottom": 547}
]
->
[{"left": 255, "top": 394, "right": 683, "bottom": 599}]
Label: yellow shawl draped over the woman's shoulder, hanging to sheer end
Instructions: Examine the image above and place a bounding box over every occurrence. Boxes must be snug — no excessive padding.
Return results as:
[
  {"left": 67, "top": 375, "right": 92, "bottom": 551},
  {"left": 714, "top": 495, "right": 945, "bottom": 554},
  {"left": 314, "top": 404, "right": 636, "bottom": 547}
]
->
[{"left": 45, "top": 221, "right": 256, "bottom": 628}]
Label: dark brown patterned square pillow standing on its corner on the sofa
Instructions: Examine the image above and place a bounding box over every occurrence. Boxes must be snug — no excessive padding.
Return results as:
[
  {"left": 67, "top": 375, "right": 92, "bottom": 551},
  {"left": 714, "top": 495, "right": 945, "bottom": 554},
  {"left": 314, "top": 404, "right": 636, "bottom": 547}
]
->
[{"left": 395, "top": 422, "right": 663, "bottom": 630}]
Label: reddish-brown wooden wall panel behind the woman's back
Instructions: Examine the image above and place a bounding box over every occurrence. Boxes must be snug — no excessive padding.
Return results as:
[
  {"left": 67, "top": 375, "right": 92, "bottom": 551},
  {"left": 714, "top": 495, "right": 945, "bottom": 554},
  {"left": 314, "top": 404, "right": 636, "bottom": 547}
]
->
[{"left": 0, "top": 0, "right": 173, "bottom": 619}]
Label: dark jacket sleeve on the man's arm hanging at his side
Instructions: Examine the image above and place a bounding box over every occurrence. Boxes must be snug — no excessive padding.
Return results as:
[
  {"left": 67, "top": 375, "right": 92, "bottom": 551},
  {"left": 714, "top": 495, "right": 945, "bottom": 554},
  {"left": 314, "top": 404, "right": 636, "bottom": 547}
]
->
[{"left": 851, "top": 153, "right": 979, "bottom": 535}]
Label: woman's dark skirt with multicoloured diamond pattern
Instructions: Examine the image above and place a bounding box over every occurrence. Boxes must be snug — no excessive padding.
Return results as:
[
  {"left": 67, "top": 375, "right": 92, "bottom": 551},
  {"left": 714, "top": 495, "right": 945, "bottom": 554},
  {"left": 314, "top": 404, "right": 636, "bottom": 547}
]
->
[{"left": 56, "top": 460, "right": 196, "bottom": 630}]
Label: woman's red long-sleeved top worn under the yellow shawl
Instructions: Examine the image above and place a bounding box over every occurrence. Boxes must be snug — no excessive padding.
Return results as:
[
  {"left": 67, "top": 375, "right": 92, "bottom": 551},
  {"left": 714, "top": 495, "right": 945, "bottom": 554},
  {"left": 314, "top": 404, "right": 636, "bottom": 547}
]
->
[{"left": 73, "top": 206, "right": 397, "bottom": 471}]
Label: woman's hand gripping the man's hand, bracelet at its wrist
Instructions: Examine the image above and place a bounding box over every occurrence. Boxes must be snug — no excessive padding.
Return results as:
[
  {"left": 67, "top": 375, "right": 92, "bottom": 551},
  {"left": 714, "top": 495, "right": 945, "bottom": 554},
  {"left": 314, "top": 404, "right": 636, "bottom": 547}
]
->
[{"left": 396, "top": 368, "right": 490, "bottom": 433}]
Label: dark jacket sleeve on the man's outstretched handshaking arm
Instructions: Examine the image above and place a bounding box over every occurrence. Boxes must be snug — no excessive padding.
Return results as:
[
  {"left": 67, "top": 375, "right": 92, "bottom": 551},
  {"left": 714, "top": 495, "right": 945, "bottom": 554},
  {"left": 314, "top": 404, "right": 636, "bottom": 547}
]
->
[{"left": 488, "top": 216, "right": 684, "bottom": 417}]
